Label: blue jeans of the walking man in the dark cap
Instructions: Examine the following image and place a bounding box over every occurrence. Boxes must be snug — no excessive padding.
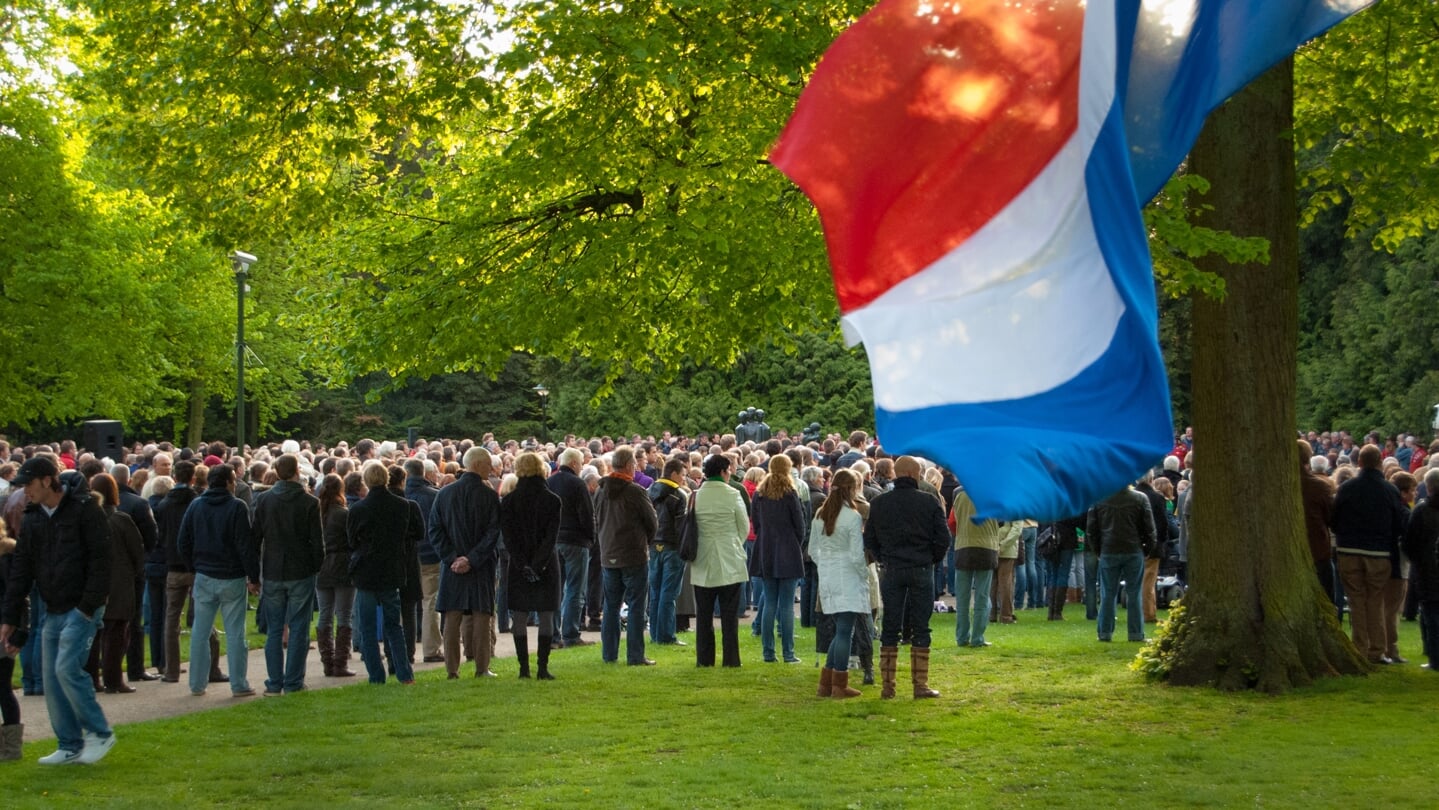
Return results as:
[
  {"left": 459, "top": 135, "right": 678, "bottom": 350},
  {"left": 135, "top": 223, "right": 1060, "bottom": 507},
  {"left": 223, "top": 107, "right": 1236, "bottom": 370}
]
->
[{"left": 40, "top": 607, "right": 111, "bottom": 751}]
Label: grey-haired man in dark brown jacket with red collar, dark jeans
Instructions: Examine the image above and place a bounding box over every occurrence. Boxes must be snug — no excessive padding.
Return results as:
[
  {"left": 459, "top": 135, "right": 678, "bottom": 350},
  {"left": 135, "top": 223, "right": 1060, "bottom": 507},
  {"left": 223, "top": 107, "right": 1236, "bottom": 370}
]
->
[{"left": 594, "top": 447, "right": 659, "bottom": 666}]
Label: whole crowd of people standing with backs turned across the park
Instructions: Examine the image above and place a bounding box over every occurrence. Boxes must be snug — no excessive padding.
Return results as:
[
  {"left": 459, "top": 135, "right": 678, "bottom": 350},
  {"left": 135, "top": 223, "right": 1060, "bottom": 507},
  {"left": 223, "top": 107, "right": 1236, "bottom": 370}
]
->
[{"left": 0, "top": 425, "right": 1439, "bottom": 764}]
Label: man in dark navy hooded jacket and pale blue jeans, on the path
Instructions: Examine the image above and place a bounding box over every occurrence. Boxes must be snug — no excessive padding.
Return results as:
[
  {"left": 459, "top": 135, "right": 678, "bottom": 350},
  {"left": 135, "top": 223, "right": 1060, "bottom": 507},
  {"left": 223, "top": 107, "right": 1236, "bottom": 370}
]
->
[{"left": 176, "top": 465, "right": 260, "bottom": 698}]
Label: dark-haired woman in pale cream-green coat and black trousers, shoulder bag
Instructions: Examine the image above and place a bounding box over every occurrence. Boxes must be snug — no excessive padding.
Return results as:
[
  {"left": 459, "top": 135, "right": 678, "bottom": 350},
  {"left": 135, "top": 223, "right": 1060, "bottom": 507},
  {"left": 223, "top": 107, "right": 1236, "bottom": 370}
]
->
[{"left": 689, "top": 456, "right": 750, "bottom": 666}]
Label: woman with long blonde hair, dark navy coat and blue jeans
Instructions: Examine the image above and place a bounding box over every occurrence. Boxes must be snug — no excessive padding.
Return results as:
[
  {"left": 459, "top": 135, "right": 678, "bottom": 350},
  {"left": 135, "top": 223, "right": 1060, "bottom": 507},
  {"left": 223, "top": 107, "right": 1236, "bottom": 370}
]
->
[{"left": 750, "top": 455, "right": 804, "bottom": 663}]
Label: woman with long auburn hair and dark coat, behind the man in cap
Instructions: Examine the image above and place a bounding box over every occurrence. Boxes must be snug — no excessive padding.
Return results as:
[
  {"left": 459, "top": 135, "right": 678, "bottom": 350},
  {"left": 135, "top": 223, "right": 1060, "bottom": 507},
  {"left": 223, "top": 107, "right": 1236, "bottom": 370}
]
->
[{"left": 88, "top": 472, "right": 145, "bottom": 695}]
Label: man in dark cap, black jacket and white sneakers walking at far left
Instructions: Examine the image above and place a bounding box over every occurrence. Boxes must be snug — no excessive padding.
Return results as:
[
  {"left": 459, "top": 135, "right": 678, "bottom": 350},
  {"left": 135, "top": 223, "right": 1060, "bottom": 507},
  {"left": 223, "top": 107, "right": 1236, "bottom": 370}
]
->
[{"left": 0, "top": 456, "right": 115, "bottom": 765}]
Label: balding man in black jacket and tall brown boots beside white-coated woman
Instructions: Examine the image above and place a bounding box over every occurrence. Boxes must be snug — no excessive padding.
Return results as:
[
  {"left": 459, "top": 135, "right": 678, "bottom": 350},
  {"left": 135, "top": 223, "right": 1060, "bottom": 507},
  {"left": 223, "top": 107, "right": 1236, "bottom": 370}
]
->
[{"left": 865, "top": 456, "right": 950, "bottom": 698}]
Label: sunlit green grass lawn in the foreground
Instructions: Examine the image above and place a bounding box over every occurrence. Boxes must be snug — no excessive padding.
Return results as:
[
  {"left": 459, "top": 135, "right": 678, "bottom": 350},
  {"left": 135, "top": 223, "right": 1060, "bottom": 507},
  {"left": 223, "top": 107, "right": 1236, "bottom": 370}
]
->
[{"left": 6, "top": 609, "right": 1439, "bottom": 809}]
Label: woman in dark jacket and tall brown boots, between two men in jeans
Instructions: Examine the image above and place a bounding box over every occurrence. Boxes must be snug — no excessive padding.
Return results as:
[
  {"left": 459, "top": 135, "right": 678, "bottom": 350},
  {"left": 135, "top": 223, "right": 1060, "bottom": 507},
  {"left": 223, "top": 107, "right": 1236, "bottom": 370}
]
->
[{"left": 315, "top": 473, "right": 355, "bottom": 678}]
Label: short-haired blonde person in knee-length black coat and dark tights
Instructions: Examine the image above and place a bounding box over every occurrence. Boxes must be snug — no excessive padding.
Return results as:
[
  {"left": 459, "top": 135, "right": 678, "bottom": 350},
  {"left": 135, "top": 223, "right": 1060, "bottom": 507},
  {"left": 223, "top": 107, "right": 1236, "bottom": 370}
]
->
[{"left": 499, "top": 453, "right": 558, "bottom": 681}]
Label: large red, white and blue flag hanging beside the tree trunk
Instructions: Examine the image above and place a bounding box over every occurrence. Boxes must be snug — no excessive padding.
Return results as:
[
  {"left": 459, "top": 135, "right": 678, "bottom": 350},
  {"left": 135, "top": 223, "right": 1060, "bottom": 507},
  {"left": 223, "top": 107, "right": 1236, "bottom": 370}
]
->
[{"left": 770, "top": 0, "right": 1364, "bottom": 518}]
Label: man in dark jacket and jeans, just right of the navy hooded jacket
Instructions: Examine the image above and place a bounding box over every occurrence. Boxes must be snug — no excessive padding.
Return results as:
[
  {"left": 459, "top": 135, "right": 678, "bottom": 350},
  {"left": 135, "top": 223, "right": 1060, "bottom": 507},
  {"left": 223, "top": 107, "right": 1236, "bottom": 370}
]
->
[{"left": 250, "top": 453, "right": 325, "bottom": 696}]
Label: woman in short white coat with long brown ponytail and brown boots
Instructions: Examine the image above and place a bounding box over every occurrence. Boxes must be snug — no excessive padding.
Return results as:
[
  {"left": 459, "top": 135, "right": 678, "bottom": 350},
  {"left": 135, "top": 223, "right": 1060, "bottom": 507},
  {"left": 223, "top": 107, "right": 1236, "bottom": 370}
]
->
[{"left": 809, "top": 469, "right": 869, "bottom": 698}]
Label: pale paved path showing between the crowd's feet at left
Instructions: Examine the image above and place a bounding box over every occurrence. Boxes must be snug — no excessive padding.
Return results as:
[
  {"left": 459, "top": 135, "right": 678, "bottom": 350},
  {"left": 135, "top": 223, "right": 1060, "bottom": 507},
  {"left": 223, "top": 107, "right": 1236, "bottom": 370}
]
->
[{"left": 16, "top": 629, "right": 589, "bottom": 742}]
